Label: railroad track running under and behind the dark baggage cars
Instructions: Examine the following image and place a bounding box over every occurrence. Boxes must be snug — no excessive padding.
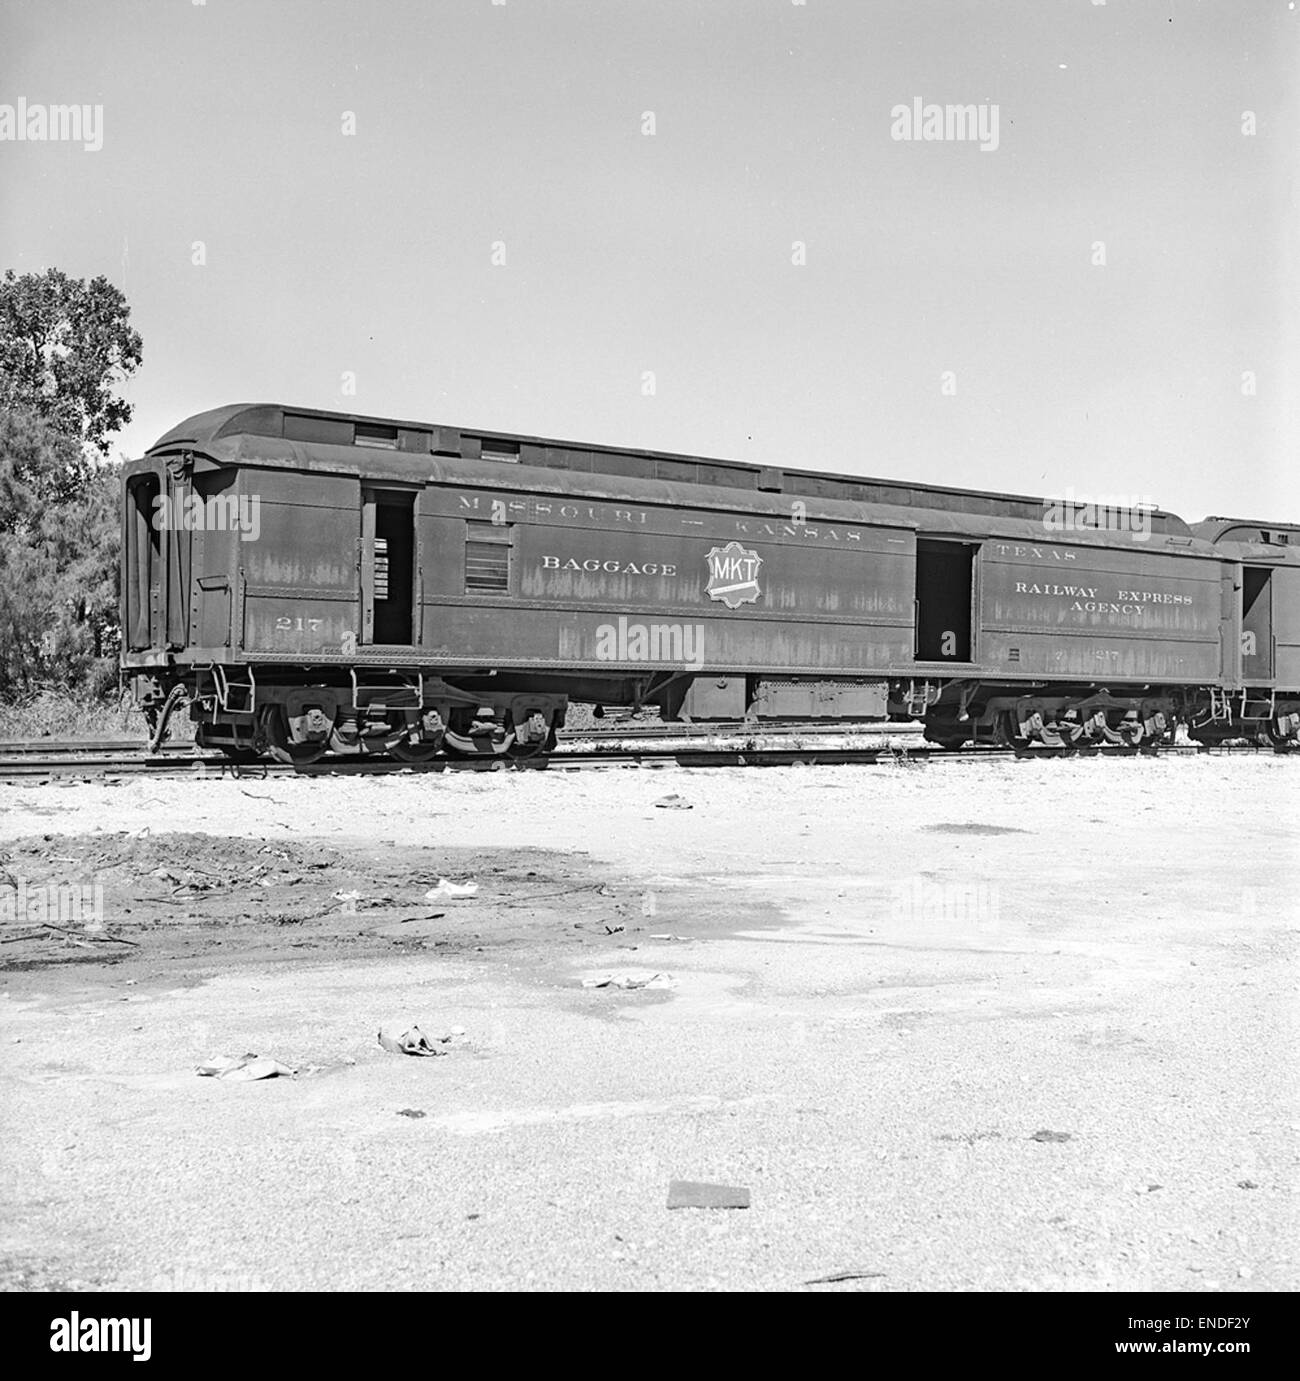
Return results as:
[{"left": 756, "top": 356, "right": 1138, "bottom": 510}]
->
[{"left": 0, "top": 725, "right": 1285, "bottom": 780}]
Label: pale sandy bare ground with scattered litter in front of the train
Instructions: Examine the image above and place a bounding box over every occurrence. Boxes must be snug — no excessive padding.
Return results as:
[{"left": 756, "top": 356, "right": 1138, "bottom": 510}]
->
[{"left": 0, "top": 757, "right": 1300, "bottom": 1290}]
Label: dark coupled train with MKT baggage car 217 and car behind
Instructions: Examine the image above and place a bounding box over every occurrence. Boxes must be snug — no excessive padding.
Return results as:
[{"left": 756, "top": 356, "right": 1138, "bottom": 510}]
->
[{"left": 123, "top": 406, "right": 1300, "bottom": 761}]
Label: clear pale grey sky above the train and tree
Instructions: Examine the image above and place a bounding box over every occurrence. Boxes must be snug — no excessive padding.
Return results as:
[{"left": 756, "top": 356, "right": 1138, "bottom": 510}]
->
[{"left": 0, "top": 0, "right": 1300, "bottom": 519}]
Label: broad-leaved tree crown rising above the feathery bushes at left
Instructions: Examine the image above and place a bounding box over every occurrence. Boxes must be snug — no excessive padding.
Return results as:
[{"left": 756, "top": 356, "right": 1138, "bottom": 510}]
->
[{"left": 0, "top": 268, "right": 142, "bottom": 454}]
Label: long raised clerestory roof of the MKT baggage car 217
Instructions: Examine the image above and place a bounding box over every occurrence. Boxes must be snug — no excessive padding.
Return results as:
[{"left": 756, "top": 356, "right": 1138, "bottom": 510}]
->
[{"left": 146, "top": 403, "right": 1192, "bottom": 537}]
